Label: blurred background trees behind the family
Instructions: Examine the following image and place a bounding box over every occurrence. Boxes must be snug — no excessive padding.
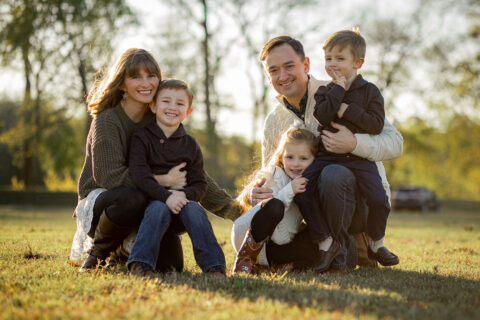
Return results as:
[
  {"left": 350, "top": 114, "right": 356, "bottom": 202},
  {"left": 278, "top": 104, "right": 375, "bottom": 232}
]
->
[{"left": 0, "top": 0, "right": 480, "bottom": 200}]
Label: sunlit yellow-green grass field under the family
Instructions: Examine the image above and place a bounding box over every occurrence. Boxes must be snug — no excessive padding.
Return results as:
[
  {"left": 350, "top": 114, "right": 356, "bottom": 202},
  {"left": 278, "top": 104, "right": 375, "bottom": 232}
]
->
[{"left": 0, "top": 206, "right": 480, "bottom": 320}]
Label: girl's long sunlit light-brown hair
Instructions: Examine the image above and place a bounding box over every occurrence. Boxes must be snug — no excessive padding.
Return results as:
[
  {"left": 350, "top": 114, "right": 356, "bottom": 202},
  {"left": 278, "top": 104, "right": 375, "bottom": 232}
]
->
[{"left": 235, "top": 126, "right": 318, "bottom": 211}]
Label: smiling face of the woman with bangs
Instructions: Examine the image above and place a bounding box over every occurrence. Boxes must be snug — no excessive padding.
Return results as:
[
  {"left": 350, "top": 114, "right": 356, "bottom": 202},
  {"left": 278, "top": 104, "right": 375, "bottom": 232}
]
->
[{"left": 121, "top": 69, "right": 159, "bottom": 105}]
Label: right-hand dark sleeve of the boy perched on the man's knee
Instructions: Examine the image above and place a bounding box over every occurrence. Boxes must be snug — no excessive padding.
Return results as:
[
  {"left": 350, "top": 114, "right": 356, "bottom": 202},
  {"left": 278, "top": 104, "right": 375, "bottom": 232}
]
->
[{"left": 343, "top": 83, "right": 385, "bottom": 134}]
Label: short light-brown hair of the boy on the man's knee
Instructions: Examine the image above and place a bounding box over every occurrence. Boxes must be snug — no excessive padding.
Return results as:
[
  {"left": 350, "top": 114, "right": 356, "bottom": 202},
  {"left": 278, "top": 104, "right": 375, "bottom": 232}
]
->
[{"left": 323, "top": 29, "right": 367, "bottom": 59}]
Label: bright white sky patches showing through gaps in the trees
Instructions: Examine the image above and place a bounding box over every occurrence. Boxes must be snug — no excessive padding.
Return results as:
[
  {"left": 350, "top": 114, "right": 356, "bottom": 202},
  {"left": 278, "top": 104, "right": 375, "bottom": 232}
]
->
[{"left": 0, "top": 0, "right": 468, "bottom": 140}]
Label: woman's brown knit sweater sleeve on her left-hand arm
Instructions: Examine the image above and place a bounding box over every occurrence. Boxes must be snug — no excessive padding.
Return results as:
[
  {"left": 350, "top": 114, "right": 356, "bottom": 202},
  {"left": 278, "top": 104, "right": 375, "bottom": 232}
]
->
[{"left": 90, "top": 116, "right": 133, "bottom": 189}]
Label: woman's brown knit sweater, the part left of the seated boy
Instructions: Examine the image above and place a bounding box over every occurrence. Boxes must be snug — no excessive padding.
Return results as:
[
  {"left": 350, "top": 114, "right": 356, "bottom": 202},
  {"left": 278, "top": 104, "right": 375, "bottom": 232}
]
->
[{"left": 78, "top": 105, "right": 153, "bottom": 199}]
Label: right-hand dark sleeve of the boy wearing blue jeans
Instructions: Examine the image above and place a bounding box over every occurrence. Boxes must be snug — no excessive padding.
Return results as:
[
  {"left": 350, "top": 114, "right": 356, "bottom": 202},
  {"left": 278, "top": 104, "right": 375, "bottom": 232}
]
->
[{"left": 183, "top": 141, "right": 207, "bottom": 202}]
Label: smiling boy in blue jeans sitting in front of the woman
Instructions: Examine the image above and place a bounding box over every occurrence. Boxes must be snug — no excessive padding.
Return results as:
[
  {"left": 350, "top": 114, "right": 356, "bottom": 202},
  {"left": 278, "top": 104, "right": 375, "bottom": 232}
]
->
[{"left": 127, "top": 80, "right": 225, "bottom": 277}]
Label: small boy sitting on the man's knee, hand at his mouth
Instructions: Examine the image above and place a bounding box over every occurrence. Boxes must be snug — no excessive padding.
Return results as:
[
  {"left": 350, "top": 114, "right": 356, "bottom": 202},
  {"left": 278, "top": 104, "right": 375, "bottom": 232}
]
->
[{"left": 295, "top": 30, "right": 399, "bottom": 272}]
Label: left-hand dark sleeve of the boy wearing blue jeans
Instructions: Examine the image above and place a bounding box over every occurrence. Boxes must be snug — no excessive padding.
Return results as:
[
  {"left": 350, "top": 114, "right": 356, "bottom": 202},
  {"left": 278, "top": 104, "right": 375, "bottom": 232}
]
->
[{"left": 129, "top": 131, "right": 172, "bottom": 202}]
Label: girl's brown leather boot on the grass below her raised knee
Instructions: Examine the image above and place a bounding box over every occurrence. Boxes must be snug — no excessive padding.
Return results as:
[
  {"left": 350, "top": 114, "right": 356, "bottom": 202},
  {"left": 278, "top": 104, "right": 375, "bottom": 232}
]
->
[{"left": 232, "top": 229, "right": 269, "bottom": 275}]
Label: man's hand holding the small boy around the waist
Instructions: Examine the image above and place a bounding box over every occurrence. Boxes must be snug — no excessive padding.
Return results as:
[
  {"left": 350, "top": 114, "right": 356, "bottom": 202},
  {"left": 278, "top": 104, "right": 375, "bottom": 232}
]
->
[{"left": 322, "top": 122, "right": 357, "bottom": 154}]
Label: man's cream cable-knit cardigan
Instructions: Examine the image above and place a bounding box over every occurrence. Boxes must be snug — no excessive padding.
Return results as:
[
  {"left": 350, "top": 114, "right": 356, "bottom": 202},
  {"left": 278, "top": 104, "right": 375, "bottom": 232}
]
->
[{"left": 262, "top": 76, "right": 403, "bottom": 198}]
